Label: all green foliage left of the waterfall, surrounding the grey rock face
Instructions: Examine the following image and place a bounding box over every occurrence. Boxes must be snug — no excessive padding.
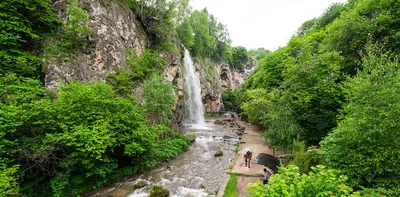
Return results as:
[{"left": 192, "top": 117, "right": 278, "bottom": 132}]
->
[{"left": 0, "top": 0, "right": 193, "bottom": 196}]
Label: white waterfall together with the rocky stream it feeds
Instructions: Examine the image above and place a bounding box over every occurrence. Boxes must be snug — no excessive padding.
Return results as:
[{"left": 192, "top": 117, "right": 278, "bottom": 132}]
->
[{"left": 86, "top": 50, "right": 239, "bottom": 197}]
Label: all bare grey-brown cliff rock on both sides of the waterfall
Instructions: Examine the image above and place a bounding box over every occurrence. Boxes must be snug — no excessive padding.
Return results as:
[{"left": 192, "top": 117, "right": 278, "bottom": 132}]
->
[{"left": 45, "top": 0, "right": 250, "bottom": 127}]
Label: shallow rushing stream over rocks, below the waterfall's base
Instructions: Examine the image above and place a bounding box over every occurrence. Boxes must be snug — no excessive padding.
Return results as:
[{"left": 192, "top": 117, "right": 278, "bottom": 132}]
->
[{"left": 89, "top": 120, "right": 238, "bottom": 197}]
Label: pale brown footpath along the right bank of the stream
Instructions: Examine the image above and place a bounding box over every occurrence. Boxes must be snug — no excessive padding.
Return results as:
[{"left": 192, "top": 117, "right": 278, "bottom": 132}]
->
[{"left": 218, "top": 121, "right": 284, "bottom": 197}]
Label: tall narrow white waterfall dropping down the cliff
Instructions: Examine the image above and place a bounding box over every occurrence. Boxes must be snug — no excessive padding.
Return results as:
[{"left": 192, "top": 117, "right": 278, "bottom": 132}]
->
[{"left": 183, "top": 49, "right": 204, "bottom": 125}]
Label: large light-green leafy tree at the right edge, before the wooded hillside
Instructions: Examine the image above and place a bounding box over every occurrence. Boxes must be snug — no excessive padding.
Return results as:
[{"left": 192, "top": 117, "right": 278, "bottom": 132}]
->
[{"left": 322, "top": 45, "right": 400, "bottom": 189}]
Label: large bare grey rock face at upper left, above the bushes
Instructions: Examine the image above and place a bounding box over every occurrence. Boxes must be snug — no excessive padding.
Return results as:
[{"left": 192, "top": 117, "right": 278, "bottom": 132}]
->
[{"left": 45, "top": 0, "right": 147, "bottom": 88}]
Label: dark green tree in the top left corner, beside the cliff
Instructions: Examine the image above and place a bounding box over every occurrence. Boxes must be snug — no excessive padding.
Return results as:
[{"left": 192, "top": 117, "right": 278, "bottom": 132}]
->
[{"left": 0, "top": 0, "right": 60, "bottom": 77}]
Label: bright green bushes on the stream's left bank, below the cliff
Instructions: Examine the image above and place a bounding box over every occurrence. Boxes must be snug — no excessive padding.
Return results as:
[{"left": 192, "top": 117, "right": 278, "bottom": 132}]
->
[{"left": 0, "top": 75, "right": 187, "bottom": 196}]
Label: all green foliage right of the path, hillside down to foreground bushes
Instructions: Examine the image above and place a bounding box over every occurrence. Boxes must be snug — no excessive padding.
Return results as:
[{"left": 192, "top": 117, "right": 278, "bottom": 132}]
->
[{"left": 241, "top": 0, "right": 400, "bottom": 196}]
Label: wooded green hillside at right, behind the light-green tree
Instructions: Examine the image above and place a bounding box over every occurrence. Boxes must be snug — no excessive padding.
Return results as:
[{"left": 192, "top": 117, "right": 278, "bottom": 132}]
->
[{"left": 243, "top": 0, "right": 400, "bottom": 150}]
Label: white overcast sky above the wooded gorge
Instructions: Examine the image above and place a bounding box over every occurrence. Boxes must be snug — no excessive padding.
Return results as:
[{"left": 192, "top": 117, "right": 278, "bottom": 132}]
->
[{"left": 191, "top": 0, "right": 347, "bottom": 51}]
